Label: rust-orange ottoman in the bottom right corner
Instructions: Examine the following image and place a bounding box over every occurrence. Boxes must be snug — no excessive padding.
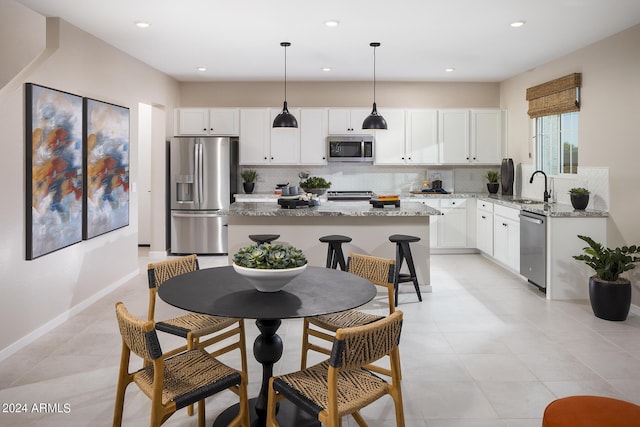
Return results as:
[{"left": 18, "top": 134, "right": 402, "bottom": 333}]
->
[{"left": 542, "top": 396, "right": 640, "bottom": 427}]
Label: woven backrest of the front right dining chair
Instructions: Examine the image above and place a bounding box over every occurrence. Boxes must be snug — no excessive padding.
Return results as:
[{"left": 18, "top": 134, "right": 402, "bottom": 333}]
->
[{"left": 329, "top": 310, "right": 402, "bottom": 370}]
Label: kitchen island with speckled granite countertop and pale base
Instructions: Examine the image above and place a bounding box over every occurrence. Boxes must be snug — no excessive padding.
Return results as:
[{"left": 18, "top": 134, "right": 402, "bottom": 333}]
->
[{"left": 228, "top": 201, "right": 440, "bottom": 292}]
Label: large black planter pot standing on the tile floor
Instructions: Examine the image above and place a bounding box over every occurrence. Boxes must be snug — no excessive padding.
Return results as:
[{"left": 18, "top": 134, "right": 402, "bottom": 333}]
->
[{"left": 589, "top": 276, "right": 631, "bottom": 321}]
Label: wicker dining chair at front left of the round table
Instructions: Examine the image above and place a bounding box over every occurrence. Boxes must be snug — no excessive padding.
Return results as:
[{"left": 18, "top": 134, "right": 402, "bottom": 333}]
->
[{"left": 113, "top": 302, "right": 249, "bottom": 427}]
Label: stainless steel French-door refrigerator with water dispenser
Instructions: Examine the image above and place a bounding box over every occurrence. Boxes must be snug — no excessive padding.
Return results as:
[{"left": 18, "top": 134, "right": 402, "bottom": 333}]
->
[{"left": 169, "top": 137, "right": 238, "bottom": 255}]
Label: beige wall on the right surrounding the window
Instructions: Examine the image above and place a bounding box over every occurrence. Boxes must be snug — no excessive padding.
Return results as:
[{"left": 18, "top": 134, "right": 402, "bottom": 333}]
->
[{"left": 501, "top": 25, "right": 640, "bottom": 305}]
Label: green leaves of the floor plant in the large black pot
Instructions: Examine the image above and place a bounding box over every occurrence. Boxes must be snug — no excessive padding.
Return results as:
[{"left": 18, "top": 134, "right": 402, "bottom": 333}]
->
[{"left": 573, "top": 235, "right": 640, "bottom": 282}]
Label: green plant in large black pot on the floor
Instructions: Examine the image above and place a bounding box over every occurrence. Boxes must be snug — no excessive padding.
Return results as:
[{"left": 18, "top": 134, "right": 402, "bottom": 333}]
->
[{"left": 573, "top": 235, "right": 640, "bottom": 320}]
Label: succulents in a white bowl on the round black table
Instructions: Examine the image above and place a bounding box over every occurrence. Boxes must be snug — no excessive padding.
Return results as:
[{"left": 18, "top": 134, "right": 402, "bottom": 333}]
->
[{"left": 233, "top": 243, "right": 307, "bottom": 292}]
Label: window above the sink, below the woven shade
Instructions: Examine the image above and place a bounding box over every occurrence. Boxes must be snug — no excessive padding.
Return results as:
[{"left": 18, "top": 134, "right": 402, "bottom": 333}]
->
[{"left": 533, "top": 112, "right": 578, "bottom": 175}]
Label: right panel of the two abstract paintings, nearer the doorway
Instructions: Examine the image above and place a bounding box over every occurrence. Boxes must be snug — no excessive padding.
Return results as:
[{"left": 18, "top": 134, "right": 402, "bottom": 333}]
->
[{"left": 82, "top": 98, "right": 129, "bottom": 239}]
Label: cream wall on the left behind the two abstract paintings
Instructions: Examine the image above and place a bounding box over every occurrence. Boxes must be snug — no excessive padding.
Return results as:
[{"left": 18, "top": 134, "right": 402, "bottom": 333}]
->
[{"left": 0, "top": 2, "right": 179, "bottom": 359}]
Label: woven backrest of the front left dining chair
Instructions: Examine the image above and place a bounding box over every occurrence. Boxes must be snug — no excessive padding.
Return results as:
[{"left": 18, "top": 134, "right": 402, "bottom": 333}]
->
[{"left": 116, "top": 302, "right": 162, "bottom": 360}]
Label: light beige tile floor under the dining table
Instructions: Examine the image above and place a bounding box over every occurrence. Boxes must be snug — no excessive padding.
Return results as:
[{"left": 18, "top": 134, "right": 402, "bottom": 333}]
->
[{"left": 0, "top": 249, "right": 640, "bottom": 427}]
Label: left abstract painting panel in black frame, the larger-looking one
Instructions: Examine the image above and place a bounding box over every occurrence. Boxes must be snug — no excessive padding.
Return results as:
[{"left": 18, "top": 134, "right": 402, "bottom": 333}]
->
[{"left": 25, "top": 83, "right": 83, "bottom": 260}]
